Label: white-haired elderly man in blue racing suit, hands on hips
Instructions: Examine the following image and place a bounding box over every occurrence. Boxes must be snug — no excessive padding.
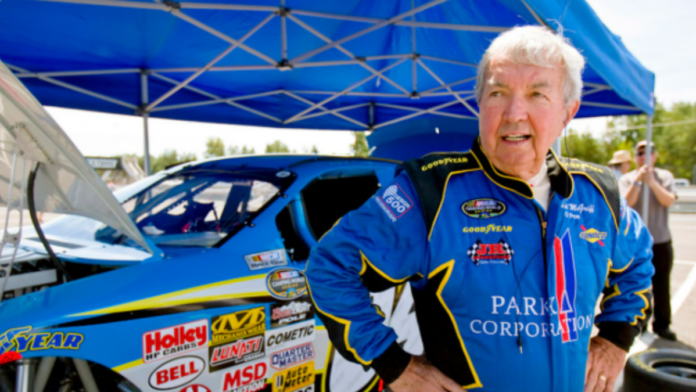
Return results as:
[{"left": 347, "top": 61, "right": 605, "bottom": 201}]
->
[{"left": 306, "top": 27, "right": 653, "bottom": 392}]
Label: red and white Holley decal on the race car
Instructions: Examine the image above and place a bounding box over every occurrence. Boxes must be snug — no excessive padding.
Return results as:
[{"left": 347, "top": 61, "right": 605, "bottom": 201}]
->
[{"left": 143, "top": 319, "right": 208, "bottom": 363}]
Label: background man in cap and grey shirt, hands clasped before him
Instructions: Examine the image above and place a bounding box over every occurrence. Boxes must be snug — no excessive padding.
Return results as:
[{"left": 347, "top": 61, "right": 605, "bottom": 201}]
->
[{"left": 619, "top": 140, "right": 677, "bottom": 340}]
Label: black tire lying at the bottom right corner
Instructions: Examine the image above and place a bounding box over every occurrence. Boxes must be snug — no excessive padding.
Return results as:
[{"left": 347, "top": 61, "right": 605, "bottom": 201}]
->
[{"left": 623, "top": 349, "right": 696, "bottom": 392}]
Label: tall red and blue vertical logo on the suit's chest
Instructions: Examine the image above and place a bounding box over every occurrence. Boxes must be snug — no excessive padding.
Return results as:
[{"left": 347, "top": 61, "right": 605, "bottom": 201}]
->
[{"left": 553, "top": 230, "right": 578, "bottom": 343}]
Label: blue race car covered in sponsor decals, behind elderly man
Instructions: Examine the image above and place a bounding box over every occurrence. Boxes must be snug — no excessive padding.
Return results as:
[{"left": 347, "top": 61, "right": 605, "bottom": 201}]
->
[{"left": 0, "top": 155, "right": 422, "bottom": 392}]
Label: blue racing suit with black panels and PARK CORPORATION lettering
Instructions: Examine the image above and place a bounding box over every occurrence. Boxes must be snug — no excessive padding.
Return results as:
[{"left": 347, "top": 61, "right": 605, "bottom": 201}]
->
[{"left": 306, "top": 141, "right": 654, "bottom": 391}]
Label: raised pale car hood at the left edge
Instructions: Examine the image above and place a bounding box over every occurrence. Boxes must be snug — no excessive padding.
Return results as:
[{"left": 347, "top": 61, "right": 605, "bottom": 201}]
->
[{"left": 0, "top": 62, "right": 152, "bottom": 253}]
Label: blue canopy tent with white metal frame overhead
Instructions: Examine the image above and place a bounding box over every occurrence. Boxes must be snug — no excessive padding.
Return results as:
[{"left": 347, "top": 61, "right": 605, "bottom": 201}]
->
[{"left": 0, "top": 0, "right": 654, "bottom": 214}]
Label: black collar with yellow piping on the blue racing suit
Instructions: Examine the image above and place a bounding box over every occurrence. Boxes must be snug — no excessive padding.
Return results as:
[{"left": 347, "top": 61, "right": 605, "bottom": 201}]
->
[{"left": 471, "top": 138, "right": 573, "bottom": 199}]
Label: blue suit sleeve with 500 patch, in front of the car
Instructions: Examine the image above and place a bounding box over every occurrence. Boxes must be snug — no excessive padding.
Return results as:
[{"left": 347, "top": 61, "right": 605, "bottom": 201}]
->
[{"left": 306, "top": 173, "right": 427, "bottom": 383}]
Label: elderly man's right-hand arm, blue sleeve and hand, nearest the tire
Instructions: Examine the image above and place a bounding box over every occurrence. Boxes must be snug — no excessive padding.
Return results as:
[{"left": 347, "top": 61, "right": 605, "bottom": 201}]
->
[{"left": 585, "top": 199, "right": 655, "bottom": 392}]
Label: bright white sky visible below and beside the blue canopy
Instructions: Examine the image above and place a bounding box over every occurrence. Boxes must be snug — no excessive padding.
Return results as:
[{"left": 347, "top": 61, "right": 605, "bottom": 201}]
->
[{"left": 48, "top": 0, "right": 696, "bottom": 157}]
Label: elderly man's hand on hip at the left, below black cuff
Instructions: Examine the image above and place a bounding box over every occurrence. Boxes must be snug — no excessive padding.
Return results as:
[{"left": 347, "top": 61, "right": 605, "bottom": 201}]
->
[{"left": 389, "top": 356, "right": 464, "bottom": 392}]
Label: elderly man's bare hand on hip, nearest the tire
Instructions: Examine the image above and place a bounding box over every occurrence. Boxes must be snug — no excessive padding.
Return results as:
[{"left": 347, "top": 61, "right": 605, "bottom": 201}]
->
[{"left": 585, "top": 336, "right": 626, "bottom": 392}]
